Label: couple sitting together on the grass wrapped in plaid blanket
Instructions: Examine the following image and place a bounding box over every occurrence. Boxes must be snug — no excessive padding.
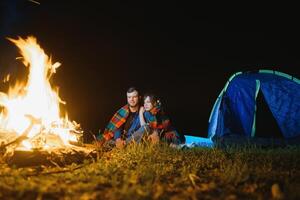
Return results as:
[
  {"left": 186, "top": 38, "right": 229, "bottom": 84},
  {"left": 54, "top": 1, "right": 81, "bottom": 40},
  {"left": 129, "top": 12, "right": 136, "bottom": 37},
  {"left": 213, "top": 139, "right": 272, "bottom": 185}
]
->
[{"left": 101, "top": 87, "right": 184, "bottom": 148}]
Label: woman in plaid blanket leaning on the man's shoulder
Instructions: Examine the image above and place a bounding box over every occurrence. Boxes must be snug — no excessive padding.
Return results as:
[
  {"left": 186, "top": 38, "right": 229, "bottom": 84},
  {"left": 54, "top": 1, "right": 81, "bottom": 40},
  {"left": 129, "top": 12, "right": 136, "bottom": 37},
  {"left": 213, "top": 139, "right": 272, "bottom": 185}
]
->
[{"left": 139, "top": 94, "right": 184, "bottom": 145}]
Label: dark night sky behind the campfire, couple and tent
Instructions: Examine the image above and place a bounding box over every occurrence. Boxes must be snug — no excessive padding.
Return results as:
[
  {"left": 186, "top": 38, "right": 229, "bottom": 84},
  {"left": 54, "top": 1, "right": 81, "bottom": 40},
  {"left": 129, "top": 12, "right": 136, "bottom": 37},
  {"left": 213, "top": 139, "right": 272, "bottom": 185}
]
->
[{"left": 0, "top": 0, "right": 300, "bottom": 141}]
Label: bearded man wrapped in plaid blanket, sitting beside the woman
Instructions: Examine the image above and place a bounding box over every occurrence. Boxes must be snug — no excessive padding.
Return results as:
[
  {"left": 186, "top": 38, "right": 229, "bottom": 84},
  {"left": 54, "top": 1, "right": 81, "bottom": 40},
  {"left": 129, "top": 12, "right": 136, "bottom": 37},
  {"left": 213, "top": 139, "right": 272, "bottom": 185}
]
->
[{"left": 103, "top": 87, "right": 148, "bottom": 148}]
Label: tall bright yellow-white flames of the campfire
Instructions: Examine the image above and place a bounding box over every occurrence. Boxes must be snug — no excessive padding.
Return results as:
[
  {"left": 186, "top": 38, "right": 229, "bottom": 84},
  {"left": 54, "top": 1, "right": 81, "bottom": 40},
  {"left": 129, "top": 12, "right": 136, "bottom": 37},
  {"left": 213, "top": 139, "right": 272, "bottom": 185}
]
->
[{"left": 0, "top": 37, "right": 94, "bottom": 167}]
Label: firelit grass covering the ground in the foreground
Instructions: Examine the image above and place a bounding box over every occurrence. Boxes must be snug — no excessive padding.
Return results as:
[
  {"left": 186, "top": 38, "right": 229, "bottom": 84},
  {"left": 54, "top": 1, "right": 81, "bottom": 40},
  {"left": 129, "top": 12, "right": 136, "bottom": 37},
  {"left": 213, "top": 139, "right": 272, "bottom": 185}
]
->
[{"left": 0, "top": 144, "right": 300, "bottom": 200}]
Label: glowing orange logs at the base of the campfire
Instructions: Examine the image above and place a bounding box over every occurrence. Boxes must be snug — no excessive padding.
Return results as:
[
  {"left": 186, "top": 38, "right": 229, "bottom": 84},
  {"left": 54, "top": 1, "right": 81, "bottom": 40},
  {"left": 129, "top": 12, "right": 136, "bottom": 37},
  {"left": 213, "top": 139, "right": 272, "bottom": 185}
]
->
[{"left": 0, "top": 127, "right": 97, "bottom": 167}]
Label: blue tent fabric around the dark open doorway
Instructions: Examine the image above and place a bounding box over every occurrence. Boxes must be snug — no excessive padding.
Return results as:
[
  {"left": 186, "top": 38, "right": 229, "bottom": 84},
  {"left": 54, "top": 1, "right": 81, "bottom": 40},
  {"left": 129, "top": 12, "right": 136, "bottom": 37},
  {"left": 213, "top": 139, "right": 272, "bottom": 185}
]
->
[{"left": 208, "top": 70, "right": 300, "bottom": 138}]
